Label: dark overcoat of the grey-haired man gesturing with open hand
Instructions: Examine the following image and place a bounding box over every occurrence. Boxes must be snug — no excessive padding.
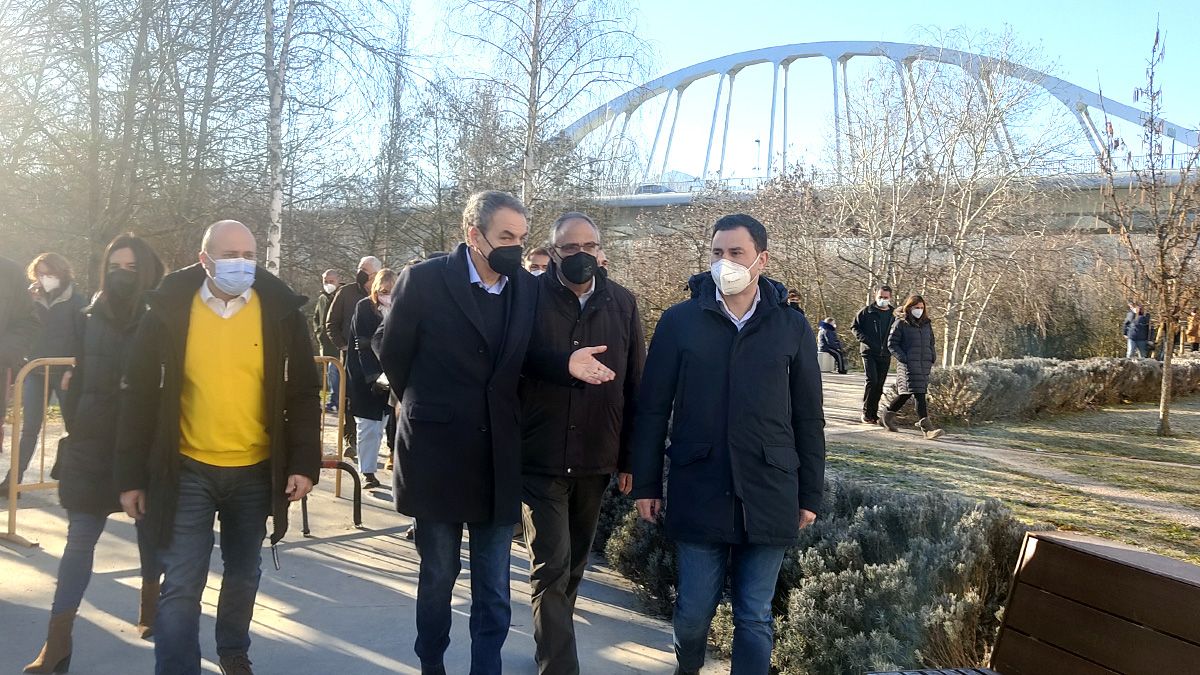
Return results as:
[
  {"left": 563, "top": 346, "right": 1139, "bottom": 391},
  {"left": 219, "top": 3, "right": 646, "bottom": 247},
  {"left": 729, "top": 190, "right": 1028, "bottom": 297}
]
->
[{"left": 379, "top": 244, "right": 570, "bottom": 525}]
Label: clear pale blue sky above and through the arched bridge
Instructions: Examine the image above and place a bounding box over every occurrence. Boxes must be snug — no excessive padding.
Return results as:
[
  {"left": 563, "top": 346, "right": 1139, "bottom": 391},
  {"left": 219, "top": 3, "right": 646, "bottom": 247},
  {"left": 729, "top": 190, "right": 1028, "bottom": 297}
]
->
[{"left": 412, "top": 0, "right": 1200, "bottom": 175}]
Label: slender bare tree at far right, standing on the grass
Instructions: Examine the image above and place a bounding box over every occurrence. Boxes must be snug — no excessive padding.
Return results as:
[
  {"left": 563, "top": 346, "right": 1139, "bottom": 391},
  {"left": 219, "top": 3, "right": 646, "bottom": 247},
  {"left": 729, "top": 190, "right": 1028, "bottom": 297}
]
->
[{"left": 1100, "top": 30, "right": 1200, "bottom": 436}]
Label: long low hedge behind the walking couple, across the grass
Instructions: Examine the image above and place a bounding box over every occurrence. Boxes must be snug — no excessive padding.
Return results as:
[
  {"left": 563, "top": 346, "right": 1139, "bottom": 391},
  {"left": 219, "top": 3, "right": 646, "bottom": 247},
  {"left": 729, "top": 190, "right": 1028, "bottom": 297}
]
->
[{"left": 888, "top": 358, "right": 1200, "bottom": 424}]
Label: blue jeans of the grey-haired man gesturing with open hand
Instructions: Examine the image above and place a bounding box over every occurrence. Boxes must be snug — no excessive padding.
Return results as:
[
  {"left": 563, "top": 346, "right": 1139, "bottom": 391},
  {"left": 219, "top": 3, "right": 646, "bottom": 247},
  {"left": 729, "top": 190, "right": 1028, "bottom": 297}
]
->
[{"left": 415, "top": 520, "right": 512, "bottom": 675}]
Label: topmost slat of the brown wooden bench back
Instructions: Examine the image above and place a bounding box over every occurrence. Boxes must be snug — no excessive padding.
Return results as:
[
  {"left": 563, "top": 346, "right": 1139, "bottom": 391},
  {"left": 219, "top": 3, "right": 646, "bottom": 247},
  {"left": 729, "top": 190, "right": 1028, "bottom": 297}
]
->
[{"left": 1019, "top": 537, "right": 1200, "bottom": 644}]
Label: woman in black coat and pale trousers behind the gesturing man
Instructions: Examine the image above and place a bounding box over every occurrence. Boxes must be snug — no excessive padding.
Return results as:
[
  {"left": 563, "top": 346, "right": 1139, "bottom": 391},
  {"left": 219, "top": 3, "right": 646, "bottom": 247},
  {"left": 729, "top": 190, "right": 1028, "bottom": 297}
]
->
[{"left": 346, "top": 269, "right": 396, "bottom": 489}]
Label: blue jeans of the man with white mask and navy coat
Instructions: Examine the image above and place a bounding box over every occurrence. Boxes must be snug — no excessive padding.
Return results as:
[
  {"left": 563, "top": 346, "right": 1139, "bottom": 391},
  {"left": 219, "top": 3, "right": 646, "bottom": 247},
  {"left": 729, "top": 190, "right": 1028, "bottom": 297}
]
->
[{"left": 676, "top": 540, "right": 786, "bottom": 675}]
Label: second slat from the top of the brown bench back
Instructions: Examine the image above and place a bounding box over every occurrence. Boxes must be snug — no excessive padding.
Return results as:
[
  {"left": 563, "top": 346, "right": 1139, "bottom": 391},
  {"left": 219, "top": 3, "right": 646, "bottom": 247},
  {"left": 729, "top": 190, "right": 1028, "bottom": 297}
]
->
[{"left": 992, "top": 580, "right": 1200, "bottom": 675}]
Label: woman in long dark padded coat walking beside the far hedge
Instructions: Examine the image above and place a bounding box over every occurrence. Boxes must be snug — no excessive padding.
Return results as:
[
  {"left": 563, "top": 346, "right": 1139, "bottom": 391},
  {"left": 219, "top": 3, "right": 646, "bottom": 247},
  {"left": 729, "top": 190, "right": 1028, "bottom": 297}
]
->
[{"left": 881, "top": 295, "right": 942, "bottom": 440}]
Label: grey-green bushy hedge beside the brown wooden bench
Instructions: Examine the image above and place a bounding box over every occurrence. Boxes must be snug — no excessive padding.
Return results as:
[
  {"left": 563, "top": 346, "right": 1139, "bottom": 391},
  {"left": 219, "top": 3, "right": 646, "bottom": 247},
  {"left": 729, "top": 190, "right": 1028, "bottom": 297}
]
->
[{"left": 606, "top": 479, "right": 1027, "bottom": 675}]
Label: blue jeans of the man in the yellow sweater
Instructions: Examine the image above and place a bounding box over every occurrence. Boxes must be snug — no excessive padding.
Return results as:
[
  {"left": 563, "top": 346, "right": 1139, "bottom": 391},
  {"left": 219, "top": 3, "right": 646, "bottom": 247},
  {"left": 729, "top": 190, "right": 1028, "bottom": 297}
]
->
[{"left": 150, "top": 458, "right": 271, "bottom": 675}]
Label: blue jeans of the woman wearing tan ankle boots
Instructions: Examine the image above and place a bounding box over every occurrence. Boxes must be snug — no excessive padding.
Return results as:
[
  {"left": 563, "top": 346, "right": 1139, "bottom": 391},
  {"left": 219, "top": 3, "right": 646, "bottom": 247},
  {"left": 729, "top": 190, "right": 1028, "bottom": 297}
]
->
[{"left": 50, "top": 510, "right": 162, "bottom": 615}]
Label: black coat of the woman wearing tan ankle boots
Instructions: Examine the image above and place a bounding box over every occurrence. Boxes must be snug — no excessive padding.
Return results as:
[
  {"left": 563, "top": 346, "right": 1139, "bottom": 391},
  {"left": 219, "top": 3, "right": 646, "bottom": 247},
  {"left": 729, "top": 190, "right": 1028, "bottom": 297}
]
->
[{"left": 54, "top": 303, "right": 142, "bottom": 514}]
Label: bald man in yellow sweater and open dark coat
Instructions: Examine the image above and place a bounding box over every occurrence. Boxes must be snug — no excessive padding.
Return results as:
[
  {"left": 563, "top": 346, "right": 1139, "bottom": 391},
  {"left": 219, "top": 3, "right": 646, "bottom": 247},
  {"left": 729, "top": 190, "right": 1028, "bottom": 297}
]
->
[{"left": 116, "top": 221, "right": 322, "bottom": 675}]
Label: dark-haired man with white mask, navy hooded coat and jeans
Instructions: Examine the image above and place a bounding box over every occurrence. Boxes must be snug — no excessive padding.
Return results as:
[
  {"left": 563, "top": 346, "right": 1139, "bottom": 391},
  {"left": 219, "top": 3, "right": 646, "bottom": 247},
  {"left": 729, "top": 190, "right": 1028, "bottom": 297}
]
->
[{"left": 631, "top": 214, "right": 824, "bottom": 675}]
